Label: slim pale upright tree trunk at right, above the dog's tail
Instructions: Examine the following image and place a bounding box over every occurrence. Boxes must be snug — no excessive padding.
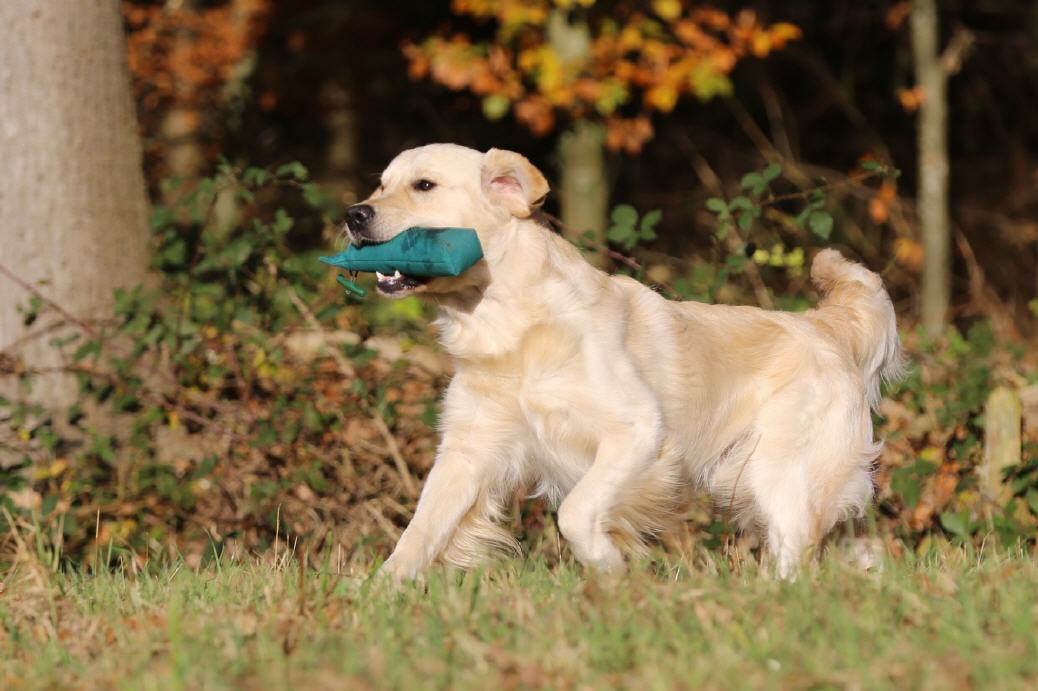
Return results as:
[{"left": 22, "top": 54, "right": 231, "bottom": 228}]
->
[{"left": 911, "top": 0, "right": 951, "bottom": 334}]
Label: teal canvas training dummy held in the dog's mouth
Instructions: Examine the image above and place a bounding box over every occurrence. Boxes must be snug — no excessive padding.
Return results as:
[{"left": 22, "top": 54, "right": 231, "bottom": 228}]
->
[{"left": 320, "top": 228, "right": 483, "bottom": 297}]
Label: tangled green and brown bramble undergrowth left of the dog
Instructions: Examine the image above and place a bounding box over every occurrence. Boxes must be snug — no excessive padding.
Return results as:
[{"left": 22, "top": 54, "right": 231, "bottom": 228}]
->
[{"left": 0, "top": 163, "right": 442, "bottom": 561}]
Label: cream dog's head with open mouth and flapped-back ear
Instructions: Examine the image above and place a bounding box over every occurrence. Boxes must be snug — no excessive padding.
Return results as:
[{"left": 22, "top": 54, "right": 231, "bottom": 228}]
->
[{"left": 346, "top": 144, "right": 548, "bottom": 297}]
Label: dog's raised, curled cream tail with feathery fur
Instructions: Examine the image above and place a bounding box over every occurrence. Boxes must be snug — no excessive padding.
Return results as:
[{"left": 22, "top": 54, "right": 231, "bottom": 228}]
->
[{"left": 811, "top": 249, "right": 904, "bottom": 408}]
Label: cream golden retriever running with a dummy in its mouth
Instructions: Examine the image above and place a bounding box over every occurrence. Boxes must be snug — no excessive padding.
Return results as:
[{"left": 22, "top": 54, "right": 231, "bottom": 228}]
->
[{"left": 347, "top": 144, "right": 901, "bottom": 578}]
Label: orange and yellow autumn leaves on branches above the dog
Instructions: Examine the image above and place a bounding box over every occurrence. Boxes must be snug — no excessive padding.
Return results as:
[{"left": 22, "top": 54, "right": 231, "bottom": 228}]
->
[{"left": 404, "top": 0, "right": 800, "bottom": 153}]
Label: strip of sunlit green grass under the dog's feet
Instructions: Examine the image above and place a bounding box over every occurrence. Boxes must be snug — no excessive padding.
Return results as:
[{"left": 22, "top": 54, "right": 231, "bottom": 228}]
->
[{"left": 0, "top": 551, "right": 1038, "bottom": 689}]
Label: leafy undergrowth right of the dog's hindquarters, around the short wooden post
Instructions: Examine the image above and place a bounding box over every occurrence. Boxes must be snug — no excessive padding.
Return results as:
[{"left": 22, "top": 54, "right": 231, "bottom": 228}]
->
[{"left": 880, "top": 322, "right": 1038, "bottom": 548}]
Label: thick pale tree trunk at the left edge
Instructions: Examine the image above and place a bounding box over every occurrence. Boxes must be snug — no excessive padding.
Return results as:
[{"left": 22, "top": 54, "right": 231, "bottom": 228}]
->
[{"left": 0, "top": 0, "right": 148, "bottom": 407}]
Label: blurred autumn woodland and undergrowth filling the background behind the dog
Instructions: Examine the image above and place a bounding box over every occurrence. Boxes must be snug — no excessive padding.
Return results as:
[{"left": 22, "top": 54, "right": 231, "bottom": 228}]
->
[{"left": 0, "top": 0, "right": 1038, "bottom": 561}]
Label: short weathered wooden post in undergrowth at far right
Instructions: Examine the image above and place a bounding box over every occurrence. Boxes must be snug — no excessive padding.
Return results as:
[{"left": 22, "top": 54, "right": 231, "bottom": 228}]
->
[{"left": 979, "top": 386, "right": 1021, "bottom": 505}]
